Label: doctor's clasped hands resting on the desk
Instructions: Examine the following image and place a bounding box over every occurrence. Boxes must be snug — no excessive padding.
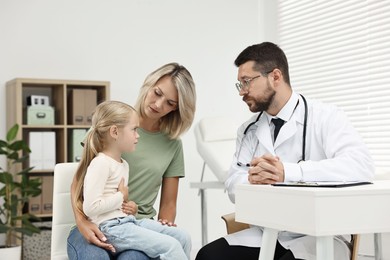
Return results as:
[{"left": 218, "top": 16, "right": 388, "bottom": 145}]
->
[{"left": 248, "top": 154, "right": 284, "bottom": 184}]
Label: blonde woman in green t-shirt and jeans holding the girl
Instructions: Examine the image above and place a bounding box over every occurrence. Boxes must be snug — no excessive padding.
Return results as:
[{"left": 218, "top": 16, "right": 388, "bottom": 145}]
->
[{"left": 68, "top": 63, "right": 196, "bottom": 260}]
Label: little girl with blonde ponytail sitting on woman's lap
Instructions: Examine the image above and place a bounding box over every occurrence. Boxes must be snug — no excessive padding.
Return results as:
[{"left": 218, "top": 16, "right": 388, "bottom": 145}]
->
[{"left": 74, "top": 101, "right": 191, "bottom": 260}]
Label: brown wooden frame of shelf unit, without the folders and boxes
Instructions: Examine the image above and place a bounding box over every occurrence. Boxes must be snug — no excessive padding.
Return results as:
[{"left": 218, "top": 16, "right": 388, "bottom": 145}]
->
[{"left": 6, "top": 78, "right": 110, "bottom": 217}]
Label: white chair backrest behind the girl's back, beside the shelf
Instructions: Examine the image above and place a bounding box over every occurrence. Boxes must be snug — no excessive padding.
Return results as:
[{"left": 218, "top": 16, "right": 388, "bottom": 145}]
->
[{"left": 51, "top": 163, "right": 78, "bottom": 260}]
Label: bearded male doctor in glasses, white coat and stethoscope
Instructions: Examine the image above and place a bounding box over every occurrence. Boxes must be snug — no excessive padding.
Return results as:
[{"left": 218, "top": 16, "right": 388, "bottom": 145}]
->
[{"left": 196, "top": 42, "right": 374, "bottom": 260}]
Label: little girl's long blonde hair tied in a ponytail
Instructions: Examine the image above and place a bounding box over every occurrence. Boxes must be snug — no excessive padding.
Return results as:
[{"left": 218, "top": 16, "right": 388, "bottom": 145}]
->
[{"left": 73, "top": 101, "right": 137, "bottom": 216}]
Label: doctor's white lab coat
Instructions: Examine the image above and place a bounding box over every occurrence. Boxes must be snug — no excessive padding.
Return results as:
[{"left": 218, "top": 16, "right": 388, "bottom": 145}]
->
[{"left": 225, "top": 92, "right": 374, "bottom": 259}]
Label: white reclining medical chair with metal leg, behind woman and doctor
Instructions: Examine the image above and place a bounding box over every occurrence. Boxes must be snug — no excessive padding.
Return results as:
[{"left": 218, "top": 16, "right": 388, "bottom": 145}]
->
[{"left": 190, "top": 117, "right": 239, "bottom": 245}]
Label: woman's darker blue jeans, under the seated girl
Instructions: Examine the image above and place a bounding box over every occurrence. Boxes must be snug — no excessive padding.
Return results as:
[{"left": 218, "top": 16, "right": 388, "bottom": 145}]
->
[{"left": 67, "top": 228, "right": 150, "bottom": 260}]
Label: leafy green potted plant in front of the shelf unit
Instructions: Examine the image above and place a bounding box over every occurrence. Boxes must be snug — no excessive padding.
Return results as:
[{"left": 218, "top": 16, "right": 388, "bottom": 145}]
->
[{"left": 0, "top": 124, "right": 41, "bottom": 259}]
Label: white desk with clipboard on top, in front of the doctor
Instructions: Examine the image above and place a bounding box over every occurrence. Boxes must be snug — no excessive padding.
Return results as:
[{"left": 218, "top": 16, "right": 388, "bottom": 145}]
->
[{"left": 236, "top": 181, "right": 390, "bottom": 260}]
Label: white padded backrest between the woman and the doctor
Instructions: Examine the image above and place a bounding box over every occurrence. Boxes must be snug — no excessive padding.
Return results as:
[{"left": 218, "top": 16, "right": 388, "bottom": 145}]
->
[{"left": 194, "top": 117, "right": 239, "bottom": 182}]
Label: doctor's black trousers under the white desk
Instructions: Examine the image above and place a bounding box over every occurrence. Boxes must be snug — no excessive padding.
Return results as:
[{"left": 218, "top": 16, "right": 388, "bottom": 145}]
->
[{"left": 195, "top": 238, "right": 296, "bottom": 260}]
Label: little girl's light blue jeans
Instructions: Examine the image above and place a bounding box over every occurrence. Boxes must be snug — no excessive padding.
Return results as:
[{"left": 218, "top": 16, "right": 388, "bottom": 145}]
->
[{"left": 99, "top": 215, "right": 191, "bottom": 260}]
